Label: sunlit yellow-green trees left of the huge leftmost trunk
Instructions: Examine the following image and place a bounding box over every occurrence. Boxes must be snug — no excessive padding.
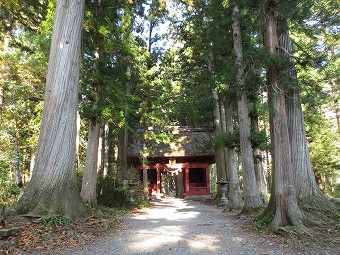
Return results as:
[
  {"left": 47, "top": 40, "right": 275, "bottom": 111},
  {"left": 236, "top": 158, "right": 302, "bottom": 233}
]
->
[{"left": 0, "top": 1, "right": 50, "bottom": 205}]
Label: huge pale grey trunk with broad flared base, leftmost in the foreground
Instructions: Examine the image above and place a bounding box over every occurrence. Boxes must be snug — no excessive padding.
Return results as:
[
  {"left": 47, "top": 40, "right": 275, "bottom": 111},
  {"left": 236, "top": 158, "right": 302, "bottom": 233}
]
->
[{"left": 8, "top": 0, "right": 87, "bottom": 220}]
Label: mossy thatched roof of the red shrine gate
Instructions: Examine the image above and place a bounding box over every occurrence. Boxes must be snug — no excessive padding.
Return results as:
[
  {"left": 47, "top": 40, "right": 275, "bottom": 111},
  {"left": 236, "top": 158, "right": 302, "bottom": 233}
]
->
[{"left": 128, "top": 127, "right": 214, "bottom": 157}]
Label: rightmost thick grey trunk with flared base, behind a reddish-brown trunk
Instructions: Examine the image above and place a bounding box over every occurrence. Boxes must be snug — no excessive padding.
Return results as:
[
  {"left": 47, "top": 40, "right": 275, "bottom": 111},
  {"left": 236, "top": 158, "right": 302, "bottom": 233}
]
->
[{"left": 279, "top": 30, "right": 332, "bottom": 209}]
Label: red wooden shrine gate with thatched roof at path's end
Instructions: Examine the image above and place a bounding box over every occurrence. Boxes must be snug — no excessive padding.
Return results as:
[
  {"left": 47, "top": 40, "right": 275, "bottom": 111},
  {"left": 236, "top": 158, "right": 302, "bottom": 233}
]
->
[{"left": 128, "top": 127, "right": 215, "bottom": 199}]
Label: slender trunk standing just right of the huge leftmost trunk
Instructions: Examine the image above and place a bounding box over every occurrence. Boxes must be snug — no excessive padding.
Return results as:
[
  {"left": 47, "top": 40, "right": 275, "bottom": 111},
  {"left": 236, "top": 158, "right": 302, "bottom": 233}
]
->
[{"left": 80, "top": 119, "right": 100, "bottom": 207}]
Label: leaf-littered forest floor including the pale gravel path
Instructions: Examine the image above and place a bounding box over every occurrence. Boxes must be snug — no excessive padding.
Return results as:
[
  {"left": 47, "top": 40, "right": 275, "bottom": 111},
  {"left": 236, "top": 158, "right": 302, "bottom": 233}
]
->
[{"left": 0, "top": 197, "right": 340, "bottom": 255}]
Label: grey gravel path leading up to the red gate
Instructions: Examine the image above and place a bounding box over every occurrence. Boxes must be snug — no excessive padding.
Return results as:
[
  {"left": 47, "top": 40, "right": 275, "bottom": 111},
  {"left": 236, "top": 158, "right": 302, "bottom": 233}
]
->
[{"left": 35, "top": 197, "right": 322, "bottom": 255}]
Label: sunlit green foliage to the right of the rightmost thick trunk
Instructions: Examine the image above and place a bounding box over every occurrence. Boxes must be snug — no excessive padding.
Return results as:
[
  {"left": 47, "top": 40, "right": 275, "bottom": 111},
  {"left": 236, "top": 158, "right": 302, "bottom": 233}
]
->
[{"left": 286, "top": 0, "right": 340, "bottom": 196}]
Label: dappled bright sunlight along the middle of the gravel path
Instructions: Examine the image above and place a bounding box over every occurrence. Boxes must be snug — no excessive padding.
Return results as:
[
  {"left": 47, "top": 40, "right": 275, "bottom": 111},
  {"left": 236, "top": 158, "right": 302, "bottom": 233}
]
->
[{"left": 129, "top": 198, "right": 223, "bottom": 254}]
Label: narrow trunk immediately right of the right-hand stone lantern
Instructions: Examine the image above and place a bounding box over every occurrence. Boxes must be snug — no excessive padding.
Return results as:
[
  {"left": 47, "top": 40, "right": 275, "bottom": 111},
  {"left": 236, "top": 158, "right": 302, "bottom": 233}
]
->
[{"left": 224, "top": 95, "right": 242, "bottom": 210}]
